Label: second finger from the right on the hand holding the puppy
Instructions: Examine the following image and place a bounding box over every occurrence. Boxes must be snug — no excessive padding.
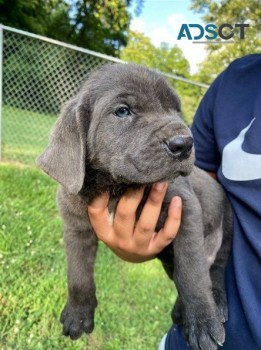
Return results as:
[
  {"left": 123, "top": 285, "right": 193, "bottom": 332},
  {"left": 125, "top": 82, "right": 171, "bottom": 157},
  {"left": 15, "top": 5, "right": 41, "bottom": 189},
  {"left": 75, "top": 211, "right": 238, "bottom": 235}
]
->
[{"left": 135, "top": 183, "right": 168, "bottom": 238}]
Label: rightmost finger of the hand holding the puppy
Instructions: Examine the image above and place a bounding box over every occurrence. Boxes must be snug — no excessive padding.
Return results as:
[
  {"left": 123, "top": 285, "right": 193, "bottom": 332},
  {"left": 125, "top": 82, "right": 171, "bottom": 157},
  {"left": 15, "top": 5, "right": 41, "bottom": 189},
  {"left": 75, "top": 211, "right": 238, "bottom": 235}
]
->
[{"left": 149, "top": 197, "right": 182, "bottom": 254}]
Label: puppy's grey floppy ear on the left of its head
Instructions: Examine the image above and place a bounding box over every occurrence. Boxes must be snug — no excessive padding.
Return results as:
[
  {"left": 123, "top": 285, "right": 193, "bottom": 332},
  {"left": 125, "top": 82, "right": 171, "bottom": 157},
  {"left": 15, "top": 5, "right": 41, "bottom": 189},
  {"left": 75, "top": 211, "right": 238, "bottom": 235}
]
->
[{"left": 36, "top": 98, "right": 88, "bottom": 194}]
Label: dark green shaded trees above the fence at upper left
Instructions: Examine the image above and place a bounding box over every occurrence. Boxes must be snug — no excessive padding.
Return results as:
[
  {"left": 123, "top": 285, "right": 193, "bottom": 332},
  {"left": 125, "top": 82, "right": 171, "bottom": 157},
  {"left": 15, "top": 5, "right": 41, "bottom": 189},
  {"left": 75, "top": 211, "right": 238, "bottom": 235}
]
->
[{"left": 0, "top": 0, "right": 143, "bottom": 56}]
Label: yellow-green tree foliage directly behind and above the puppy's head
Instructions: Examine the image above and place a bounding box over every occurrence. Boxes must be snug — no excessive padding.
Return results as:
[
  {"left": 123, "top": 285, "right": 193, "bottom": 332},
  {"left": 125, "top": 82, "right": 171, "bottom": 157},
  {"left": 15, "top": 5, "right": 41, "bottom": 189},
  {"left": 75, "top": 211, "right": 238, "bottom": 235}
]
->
[{"left": 120, "top": 32, "right": 205, "bottom": 124}]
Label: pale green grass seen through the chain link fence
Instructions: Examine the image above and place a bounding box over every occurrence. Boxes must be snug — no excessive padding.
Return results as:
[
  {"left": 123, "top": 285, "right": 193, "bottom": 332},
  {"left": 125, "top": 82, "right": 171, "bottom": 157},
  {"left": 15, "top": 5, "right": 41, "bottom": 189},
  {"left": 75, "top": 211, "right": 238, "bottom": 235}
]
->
[{"left": 2, "top": 106, "right": 56, "bottom": 164}]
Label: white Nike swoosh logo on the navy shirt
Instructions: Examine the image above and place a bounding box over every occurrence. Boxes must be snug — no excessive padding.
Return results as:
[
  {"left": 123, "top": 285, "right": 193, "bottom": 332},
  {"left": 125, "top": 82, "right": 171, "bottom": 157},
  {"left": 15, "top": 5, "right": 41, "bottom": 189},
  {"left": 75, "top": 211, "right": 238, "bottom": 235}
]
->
[{"left": 222, "top": 118, "right": 261, "bottom": 181}]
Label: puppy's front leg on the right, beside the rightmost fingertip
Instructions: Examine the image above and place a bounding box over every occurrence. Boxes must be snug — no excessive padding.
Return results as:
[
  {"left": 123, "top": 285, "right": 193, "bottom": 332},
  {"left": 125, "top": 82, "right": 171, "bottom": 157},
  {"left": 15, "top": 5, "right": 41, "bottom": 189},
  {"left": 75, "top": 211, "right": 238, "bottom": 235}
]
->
[{"left": 173, "top": 196, "right": 225, "bottom": 350}]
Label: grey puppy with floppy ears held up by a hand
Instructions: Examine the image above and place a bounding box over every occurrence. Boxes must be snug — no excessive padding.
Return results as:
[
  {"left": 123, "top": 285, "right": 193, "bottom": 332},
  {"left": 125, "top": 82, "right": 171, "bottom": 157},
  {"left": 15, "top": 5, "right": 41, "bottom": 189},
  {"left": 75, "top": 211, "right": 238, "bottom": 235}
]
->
[{"left": 37, "top": 64, "right": 231, "bottom": 350}]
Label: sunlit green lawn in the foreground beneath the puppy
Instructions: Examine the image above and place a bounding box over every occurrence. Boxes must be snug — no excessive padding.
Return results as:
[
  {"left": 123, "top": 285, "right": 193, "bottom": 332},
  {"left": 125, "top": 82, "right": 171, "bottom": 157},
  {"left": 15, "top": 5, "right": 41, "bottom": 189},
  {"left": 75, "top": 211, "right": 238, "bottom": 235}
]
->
[{"left": 0, "top": 165, "right": 175, "bottom": 350}]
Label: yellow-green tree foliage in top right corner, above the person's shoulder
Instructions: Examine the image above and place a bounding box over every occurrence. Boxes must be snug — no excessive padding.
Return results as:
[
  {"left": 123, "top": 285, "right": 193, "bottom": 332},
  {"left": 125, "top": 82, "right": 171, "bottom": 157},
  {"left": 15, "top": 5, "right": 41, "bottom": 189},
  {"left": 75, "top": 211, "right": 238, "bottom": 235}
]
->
[{"left": 191, "top": 0, "right": 261, "bottom": 83}]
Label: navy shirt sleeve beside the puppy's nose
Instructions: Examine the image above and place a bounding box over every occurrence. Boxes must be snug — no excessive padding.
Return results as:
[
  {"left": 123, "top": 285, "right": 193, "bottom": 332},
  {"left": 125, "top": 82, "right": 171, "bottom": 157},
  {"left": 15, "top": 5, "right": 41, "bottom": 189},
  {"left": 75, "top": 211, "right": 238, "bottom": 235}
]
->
[{"left": 191, "top": 73, "right": 223, "bottom": 172}]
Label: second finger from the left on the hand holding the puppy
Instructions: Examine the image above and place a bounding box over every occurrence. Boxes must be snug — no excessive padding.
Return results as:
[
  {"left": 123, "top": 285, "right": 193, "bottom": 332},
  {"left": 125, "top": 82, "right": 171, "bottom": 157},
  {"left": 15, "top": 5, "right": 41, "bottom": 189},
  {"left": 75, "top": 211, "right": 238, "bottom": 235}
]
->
[{"left": 113, "top": 188, "right": 144, "bottom": 237}]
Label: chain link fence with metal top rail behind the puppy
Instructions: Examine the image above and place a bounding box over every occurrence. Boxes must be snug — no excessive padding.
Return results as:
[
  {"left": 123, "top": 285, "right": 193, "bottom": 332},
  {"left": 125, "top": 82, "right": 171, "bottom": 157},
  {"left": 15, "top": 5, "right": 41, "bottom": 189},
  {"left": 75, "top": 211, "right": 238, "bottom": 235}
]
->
[{"left": 0, "top": 25, "right": 206, "bottom": 164}]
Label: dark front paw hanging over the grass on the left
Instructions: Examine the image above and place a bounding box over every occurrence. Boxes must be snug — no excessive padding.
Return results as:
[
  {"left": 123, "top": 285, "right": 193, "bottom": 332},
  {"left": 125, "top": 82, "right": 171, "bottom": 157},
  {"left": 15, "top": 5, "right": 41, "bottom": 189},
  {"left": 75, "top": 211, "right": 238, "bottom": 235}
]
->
[{"left": 60, "top": 303, "right": 94, "bottom": 340}]
